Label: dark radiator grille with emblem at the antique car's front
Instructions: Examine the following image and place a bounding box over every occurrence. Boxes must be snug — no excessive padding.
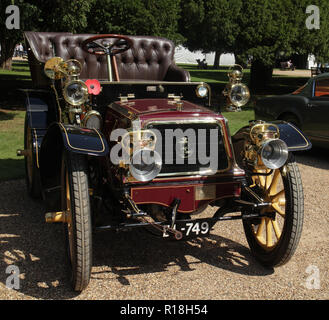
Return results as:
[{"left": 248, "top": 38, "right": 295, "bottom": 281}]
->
[{"left": 148, "top": 123, "right": 228, "bottom": 177}]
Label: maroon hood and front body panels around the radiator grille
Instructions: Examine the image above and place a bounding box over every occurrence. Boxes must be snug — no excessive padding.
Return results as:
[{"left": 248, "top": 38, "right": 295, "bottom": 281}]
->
[{"left": 104, "top": 99, "right": 245, "bottom": 213}]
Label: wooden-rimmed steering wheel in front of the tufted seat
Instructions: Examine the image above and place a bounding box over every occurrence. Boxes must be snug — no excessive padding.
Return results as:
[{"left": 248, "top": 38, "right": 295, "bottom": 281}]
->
[{"left": 82, "top": 34, "right": 133, "bottom": 56}]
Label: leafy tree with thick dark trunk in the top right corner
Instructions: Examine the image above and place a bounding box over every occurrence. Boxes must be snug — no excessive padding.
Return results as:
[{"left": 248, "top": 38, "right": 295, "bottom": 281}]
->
[{"left": 235, "top": 0, "right": 329, "bottom": 89}]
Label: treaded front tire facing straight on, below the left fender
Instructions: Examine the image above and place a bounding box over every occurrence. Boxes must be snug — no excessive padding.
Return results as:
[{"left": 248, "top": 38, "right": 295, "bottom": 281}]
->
[{"left": 62, "top": 153, "right": 92, "bottom": 291}]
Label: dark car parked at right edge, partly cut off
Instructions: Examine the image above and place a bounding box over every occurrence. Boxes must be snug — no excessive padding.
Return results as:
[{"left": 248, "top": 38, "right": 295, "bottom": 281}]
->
[{"left": 255, "top": 73, "right": 329, "bottom": 148}]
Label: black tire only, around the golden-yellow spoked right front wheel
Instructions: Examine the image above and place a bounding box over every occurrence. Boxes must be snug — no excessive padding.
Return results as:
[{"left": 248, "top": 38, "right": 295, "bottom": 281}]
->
[{"left": 243, "top": 154, "right": 304, "bottom": 267}]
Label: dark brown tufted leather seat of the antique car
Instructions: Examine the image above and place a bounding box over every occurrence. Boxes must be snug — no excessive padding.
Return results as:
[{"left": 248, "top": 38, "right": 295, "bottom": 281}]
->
[{"left": 24, "top": 31, "right": 190, "bottom": 86}]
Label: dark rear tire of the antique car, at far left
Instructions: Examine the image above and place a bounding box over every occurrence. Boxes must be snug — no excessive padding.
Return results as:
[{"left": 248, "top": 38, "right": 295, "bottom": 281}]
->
[{"left": 24, "top": 115, "right": 42, "bottom": 199}]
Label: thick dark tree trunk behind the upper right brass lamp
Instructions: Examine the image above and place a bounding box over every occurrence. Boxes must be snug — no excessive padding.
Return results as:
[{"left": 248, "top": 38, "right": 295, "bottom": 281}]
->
[{"left": 249, "top": 60, "right": 273, "bottom": 93}]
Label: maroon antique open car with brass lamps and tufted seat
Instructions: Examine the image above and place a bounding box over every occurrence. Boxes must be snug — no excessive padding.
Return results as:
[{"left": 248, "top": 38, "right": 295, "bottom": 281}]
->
[{"left": 18, "top": 32, "right": 311, "bottom": 291}]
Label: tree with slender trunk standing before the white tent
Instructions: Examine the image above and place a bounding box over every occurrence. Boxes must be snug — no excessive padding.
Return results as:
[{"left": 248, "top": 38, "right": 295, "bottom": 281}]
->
[{"left": 180, "top": 0, "right": 242, "bottom": 68}]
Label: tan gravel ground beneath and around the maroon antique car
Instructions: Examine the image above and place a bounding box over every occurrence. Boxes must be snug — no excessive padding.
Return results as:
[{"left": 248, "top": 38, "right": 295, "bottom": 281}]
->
[{"left": 0, "top": 151, "right": 329, "bottom": 300}]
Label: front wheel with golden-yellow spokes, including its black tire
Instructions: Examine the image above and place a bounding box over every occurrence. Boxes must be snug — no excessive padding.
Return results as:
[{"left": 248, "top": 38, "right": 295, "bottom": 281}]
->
[{"left": 243, "top": 155, "right": 304, "bottom": 267}]
